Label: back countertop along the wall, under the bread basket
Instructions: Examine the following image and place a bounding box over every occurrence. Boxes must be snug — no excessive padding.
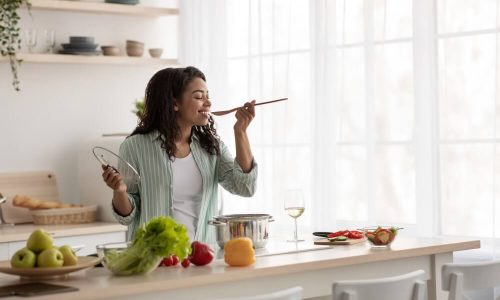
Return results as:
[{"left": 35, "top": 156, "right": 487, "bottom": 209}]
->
[{"left": 0, "top": 222, "right": 127, "bottom": 243}]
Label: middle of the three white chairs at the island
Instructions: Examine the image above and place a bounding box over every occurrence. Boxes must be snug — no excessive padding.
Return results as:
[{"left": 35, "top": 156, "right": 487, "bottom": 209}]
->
[{"left": 332, "top": 270, "right": 427, "bottom": 300}]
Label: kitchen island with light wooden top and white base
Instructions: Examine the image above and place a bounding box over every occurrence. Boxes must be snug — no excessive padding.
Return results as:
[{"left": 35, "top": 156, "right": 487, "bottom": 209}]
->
[{"left": 0, "top": 237, "right": 480, "bottom": 300}]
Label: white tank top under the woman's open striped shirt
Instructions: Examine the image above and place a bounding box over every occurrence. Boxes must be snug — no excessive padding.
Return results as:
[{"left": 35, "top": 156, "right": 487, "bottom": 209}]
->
[{"left": 172, "top": 153, "right": 203, "bottom": 241}]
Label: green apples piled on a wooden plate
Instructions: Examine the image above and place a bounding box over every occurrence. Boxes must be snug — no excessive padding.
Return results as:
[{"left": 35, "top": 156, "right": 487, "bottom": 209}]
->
[{"left": 0, "top": 229, "right": 100, "bottom": 277}]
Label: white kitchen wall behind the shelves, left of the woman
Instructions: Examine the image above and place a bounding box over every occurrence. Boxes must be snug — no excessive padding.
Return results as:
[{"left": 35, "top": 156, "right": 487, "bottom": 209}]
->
[{"left": 0, "top": 0, "right": 178, "bottom": 203}]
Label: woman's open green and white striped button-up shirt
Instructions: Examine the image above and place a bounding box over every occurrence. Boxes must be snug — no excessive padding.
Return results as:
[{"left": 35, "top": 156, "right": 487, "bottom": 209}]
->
[{"left": 113, "top": 132, "right": 257, "bottom": 244}]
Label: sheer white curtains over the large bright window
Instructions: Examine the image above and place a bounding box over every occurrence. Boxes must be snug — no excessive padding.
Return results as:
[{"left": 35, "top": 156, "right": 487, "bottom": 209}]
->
[{"left": 180, "top": 0, "right": 500, "bottom": 256}]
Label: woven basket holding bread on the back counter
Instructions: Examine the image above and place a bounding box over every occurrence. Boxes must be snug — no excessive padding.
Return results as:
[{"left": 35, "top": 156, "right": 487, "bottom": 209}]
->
[{"left": 31, "top": 205, "right": 97, "bottom": 225}]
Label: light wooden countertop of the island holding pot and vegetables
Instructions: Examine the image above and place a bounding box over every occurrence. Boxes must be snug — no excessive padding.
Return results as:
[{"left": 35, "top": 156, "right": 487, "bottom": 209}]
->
[{"left": 0, "top": 237, "right": 480, "bottom": 300}]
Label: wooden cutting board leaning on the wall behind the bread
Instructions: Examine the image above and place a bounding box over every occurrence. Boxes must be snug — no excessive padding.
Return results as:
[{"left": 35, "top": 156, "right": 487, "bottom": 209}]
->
[{"left": 0, "top": 171, "right": 59, "bottom": 224}]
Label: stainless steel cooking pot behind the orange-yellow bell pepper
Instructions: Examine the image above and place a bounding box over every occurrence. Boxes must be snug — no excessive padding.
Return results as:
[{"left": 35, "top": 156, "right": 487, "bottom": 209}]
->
[{"left": 208, "top": 214, "right": 274, "bottom": 249}]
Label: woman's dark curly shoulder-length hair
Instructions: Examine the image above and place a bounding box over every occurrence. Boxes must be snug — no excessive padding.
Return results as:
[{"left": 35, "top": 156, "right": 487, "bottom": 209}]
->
[{"left": 131, "top": 67, "right": 220, "bottom": 160}]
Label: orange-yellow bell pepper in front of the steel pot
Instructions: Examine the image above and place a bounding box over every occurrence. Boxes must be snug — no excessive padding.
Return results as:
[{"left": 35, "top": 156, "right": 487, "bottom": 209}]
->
[{"left": 224, "top": 237, "right": 255, "bottom": 267}]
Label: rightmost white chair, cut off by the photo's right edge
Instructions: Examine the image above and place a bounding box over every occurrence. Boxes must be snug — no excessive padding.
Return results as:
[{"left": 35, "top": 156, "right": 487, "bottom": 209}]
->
[{"left": 442, "top": 261, "right": 500, "bottom": 300}]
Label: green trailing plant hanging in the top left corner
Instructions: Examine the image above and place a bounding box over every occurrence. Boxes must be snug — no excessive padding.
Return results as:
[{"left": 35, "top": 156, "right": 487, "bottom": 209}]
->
[{"left": 0, "top": 0, "right": 31, "bottom": 91}]
